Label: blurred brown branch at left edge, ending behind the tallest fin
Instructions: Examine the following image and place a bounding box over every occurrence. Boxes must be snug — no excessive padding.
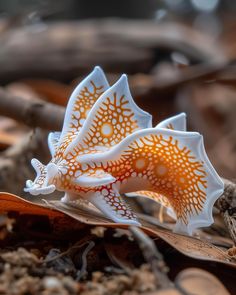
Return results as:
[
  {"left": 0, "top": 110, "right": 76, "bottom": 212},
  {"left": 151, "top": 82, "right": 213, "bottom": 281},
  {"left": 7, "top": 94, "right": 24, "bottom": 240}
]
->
[{"left": 0, "top": 88, "right": 65, "bottom": 130}]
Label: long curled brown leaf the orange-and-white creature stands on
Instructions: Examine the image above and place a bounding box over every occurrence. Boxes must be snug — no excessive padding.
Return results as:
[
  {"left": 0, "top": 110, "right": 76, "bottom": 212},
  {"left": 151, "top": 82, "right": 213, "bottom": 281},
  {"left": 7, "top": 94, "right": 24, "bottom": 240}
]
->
[{"left": 0, "top": 193, "right": 236, "bottom": 267}]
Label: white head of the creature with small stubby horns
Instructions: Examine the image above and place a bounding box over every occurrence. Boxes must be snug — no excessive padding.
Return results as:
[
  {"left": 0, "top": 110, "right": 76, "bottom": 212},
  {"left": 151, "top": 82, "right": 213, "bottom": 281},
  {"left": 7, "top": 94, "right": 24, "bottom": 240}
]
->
[{"left": 24, "top": 159, "right": 58, "bottom": 196}]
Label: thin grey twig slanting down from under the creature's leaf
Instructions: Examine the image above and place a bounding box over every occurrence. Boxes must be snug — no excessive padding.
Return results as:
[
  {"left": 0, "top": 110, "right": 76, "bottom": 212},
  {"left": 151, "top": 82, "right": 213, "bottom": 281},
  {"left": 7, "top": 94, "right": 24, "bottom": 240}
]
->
[{"left": 130, "top": 226, "right": 173, "bottom": 288}]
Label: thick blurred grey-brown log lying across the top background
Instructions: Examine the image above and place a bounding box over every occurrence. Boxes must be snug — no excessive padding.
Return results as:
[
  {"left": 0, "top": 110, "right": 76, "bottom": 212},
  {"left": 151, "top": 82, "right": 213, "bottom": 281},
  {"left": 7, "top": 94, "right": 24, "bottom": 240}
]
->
[{"left": 0, "top": 19, "right": 225, "bottom": 84}]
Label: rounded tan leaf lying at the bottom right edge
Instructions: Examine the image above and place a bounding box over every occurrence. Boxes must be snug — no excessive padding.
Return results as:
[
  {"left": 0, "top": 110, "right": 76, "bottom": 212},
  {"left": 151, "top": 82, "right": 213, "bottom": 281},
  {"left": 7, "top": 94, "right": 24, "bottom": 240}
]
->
[{"left": 176, "top": 268, "right": 230, "bottom": 295}]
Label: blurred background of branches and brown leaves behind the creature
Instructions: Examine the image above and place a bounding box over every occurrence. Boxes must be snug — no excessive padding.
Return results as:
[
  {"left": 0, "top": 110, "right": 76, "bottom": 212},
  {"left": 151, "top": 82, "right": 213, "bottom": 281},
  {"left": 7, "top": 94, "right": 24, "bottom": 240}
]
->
[{"left": 0, "top": 0, "right": 236, "bottom": 193}]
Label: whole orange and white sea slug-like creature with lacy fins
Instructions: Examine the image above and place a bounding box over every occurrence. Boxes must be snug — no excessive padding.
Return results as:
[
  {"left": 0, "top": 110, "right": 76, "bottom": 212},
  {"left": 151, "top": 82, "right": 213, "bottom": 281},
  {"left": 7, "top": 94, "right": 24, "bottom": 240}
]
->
[{"left": 25, "top": 67, "right": 223, "bottom": 234}]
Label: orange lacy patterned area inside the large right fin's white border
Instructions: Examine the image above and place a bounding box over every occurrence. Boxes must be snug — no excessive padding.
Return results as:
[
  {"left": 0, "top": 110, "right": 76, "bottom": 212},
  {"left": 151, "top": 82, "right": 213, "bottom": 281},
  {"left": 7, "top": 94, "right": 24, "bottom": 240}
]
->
[{"left": 104, "top": 134, "right": 207, "bottom": 224}]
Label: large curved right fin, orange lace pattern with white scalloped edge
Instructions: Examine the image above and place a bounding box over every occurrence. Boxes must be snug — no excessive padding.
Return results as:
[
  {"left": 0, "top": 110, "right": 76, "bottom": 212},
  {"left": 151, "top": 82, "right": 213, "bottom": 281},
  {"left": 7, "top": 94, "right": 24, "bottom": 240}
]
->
[{"left": 94, "top": 128, "right": 223, "bottom": 234}]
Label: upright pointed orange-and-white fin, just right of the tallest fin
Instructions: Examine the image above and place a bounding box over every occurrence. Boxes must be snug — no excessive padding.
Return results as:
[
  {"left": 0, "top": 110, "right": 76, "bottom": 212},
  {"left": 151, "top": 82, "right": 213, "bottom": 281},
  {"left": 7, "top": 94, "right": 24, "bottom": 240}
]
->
[{"left": 66, "top": 75, "right": 152, "bottom": 155}]
